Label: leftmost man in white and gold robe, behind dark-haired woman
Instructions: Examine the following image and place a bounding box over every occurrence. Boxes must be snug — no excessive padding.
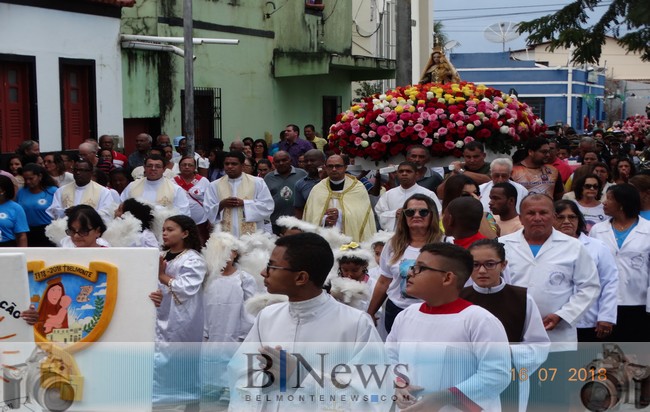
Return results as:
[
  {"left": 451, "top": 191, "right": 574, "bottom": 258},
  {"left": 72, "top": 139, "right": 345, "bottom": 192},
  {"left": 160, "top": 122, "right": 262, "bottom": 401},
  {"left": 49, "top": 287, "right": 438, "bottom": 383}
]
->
[{"left": 47, "top": 159, "right": 113, "bottom": 222}]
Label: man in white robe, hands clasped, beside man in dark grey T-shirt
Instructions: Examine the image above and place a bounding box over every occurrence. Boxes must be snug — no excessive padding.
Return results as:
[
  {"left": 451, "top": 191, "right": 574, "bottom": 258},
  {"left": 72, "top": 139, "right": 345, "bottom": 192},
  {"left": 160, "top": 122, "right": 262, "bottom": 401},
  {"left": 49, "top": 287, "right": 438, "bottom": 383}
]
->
[{"left": 203, "top": 152, "right": 275, "bottom": 237}]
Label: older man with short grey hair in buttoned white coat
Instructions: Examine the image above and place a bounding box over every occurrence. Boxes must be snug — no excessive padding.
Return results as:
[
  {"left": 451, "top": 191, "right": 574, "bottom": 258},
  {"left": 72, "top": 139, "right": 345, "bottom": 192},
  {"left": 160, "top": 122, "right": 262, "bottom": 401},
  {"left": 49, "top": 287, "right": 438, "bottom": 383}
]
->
[{"left": 499, "top": 193, "right": 600, "bottom": 410}]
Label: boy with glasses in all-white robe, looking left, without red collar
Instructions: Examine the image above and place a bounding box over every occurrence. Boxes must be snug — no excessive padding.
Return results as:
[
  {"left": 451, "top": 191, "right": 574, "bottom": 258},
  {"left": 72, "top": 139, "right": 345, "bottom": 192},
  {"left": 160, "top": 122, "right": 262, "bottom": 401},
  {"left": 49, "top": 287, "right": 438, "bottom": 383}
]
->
[{"left": 228, "top": 233, "right": 392, "bottom": 411}]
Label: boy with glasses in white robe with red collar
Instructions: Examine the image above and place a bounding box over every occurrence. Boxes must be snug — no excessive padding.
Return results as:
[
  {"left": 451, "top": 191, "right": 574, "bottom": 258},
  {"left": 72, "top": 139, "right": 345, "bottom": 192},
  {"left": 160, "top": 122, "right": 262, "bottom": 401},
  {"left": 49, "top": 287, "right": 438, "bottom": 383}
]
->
[{"left": 386, "top": 243, "right": 510, "bottom": 411}]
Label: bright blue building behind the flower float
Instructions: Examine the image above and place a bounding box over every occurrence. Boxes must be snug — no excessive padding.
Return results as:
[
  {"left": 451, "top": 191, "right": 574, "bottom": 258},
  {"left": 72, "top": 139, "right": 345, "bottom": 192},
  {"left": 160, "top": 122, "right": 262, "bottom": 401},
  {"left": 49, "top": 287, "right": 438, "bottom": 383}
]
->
[{"left": 450, "top": 52, "right": 605, "bottom": 131}]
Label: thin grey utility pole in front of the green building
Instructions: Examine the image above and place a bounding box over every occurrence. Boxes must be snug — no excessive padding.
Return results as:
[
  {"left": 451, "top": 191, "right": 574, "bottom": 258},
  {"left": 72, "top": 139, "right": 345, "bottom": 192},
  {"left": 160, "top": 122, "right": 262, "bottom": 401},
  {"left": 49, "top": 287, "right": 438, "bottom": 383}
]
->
[{"left": 183, "top": 0, "right": 194, "bottom": 156}]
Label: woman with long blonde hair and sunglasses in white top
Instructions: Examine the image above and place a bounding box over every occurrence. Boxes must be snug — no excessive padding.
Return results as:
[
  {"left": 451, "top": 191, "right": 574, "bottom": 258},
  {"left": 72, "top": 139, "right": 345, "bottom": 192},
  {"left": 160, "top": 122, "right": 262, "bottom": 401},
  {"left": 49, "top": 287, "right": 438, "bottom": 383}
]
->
[{"left": 368, "top": 193, "right": 442, "bottom": 332}]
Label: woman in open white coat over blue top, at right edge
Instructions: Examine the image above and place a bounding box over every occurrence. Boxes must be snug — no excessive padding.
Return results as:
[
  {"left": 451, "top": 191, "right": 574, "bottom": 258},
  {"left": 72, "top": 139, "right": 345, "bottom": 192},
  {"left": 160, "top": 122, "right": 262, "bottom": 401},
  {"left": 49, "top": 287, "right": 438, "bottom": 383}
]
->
[{"left": 590, "top": 183, "right": 650, "bottom": 342}]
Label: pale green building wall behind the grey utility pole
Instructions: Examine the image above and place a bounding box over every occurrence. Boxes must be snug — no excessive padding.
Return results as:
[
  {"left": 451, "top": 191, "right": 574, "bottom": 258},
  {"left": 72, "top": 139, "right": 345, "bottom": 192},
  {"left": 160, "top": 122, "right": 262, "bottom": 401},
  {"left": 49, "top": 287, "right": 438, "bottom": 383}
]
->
[{"left": 122, "top": 0, "right": 360, "bottom": 144}]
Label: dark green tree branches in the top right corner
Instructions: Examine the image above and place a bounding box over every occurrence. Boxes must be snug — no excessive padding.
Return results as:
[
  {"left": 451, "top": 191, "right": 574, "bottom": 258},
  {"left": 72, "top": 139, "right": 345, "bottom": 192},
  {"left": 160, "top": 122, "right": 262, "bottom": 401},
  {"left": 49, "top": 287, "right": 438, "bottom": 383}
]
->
[{"left": 518, "top": 0, "right": 650, "bottom": 64}]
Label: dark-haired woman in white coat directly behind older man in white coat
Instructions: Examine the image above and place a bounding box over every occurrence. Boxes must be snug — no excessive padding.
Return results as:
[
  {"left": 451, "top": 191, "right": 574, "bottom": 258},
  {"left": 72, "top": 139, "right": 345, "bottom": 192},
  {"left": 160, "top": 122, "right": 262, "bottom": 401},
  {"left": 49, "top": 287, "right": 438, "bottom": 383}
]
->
[{"left": 555, "top": 200, "right": 618, "bottom": 342}]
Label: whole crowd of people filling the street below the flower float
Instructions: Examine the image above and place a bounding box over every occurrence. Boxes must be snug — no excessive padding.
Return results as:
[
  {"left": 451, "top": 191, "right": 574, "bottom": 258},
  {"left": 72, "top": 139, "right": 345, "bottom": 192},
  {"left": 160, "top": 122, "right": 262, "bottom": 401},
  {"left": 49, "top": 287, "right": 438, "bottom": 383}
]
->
[{"left": 7, "top": 120, "right": 650, "bottom": 410}]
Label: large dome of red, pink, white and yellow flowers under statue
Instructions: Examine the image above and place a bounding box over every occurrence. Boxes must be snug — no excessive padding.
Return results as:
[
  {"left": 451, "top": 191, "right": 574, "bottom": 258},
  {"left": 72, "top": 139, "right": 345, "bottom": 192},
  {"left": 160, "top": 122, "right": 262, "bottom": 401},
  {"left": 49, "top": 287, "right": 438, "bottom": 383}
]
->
[{"left": 328, "top": 82, "right": 546, "bottom": 161}]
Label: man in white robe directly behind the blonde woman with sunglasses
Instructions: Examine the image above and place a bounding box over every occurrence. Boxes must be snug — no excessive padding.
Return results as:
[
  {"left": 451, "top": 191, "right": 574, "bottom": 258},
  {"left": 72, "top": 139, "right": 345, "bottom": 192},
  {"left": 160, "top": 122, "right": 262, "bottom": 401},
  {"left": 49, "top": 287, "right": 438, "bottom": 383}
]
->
[{"left": 375, "top": 162, "right": 442, "bottom": 232}]
